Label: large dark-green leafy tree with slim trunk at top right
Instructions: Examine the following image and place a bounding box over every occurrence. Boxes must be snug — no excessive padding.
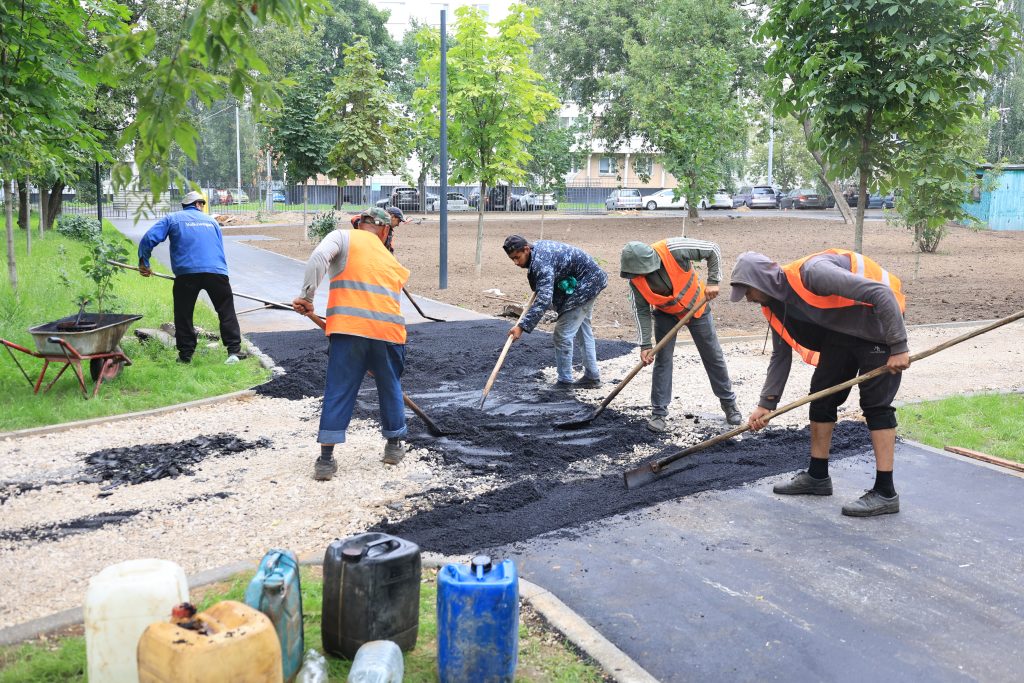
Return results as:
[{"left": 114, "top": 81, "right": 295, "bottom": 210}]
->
[{"left": 760, "top": 0, "right": 1020, "bottom": 251}]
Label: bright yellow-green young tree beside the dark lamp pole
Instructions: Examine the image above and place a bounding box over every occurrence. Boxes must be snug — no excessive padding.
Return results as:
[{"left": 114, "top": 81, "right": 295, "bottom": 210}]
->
[{"left": 415, "top": 5, "right": 558, "bottom": 276}]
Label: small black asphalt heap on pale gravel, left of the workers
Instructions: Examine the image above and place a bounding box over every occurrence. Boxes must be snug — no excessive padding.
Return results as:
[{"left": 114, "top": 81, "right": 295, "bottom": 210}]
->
[{"left": 85, "top": 434, "right": 270, "bottom": 490}]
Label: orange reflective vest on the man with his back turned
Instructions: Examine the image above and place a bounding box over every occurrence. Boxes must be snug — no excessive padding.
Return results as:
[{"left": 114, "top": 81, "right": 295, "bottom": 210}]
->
[{"left": 326, "top": 230, "right": 409, "bottom": 344}]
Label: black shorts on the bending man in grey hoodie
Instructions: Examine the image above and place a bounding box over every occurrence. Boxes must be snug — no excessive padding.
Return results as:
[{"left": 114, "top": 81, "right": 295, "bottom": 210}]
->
[{"left": 810, "top": 335, "right": 902, "bottom": 430}]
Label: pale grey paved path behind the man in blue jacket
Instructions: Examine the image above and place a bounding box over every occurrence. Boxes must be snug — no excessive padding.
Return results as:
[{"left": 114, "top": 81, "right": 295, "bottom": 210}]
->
[{"left": 111, "top": 218, "right": 487, "bottom": 333}]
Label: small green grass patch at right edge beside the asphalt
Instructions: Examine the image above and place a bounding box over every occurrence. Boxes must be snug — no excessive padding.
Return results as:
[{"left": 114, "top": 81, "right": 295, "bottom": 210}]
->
[{"left": 898, "top": 394, "right": 1024, "bottom": 463}]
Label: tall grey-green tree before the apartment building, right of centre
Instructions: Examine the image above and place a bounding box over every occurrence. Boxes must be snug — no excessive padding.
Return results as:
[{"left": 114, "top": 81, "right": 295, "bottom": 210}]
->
[{"left": 627, "top": 0, "right": 752, "bottom": 218}]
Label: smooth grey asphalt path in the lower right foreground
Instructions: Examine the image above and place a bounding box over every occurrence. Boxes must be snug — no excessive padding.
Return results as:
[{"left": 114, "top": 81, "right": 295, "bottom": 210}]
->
[{"left": 506, "top": 443, "right": 1024, "bottom": 682}]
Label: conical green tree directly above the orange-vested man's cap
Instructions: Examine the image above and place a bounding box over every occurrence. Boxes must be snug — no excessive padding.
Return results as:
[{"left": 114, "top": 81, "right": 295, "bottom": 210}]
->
[{"left": 317, "top": 38, "right": 408, "bottom": 208}]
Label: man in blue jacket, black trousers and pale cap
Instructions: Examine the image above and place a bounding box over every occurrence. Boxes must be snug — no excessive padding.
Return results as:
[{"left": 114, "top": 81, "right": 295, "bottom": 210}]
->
[{"left": 138, "top": 191, "right": 242, "bottom": 365}]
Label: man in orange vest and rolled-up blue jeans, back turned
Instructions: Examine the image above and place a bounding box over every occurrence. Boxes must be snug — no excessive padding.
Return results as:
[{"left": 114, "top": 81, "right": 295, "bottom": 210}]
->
[{"left": 292, "top": 208, "right": 409, "bottom": 481}]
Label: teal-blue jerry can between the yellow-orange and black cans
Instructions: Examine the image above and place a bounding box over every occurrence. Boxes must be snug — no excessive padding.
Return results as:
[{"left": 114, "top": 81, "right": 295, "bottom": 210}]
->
[{"left": 246, "top": 548, "right": 305, "bottom": 681}]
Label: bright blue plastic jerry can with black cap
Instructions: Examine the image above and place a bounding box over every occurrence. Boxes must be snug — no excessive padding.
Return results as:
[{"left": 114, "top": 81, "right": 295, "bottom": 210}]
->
[{"left": 437, "top": 555, "right": 519, "bottom": 683}]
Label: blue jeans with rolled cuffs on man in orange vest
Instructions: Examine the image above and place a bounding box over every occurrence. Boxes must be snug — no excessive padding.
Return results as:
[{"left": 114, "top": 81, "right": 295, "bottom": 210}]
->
[{"left": 316, "top": 335, "right": 407, "bottom": 443}]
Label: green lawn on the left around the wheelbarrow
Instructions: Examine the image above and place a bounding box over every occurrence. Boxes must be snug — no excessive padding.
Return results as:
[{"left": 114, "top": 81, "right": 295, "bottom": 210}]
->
[{"left": 0, "top": 216, "right": 268, "bottom": 431}]
